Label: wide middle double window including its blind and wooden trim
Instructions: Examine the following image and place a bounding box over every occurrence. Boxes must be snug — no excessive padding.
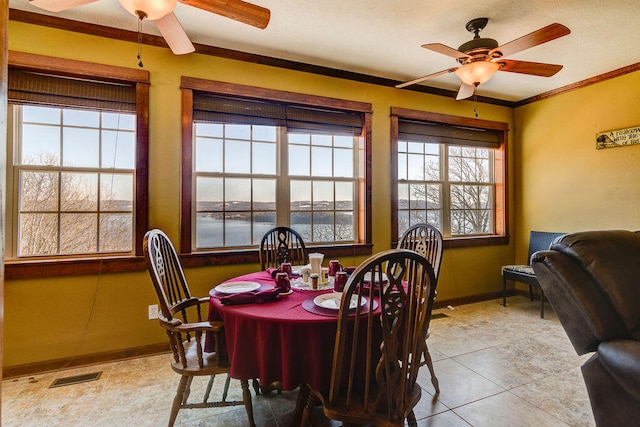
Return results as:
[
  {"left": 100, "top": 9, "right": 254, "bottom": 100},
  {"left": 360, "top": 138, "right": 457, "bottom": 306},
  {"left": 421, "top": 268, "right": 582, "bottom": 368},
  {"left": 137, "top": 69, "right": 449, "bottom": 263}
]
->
[{"left": 182, "top": 78, "right": 370, "bottom": 262}]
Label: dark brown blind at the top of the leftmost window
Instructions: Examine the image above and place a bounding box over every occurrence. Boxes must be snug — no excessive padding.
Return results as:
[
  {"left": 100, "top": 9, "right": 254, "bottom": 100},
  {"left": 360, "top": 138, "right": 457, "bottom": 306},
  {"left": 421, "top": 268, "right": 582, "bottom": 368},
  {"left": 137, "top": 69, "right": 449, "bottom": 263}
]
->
[{"left": 8, "top": 68, "right": 136, "bottom": 112}]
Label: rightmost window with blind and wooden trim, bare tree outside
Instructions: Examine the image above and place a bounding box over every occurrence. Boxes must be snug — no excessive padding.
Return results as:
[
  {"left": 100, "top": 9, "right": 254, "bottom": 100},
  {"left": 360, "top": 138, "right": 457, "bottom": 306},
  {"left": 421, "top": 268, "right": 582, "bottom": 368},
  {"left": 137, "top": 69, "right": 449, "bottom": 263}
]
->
[{"left": 392, "top": 108, "right": 506, "bottom": 247}]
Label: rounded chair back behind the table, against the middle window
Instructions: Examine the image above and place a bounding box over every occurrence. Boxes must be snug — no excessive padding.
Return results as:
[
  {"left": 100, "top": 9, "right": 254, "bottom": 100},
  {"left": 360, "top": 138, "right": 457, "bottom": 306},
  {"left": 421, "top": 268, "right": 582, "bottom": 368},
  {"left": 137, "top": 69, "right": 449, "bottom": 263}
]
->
[{"left": 260, "top": 227, "right": 307, "bottom": 270}]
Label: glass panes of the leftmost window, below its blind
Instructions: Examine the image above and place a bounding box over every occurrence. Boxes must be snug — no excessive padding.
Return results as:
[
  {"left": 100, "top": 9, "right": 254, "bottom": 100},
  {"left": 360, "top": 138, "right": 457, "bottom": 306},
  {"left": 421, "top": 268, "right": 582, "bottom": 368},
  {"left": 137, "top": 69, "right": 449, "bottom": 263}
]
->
[{"left": 11, "top": 104, "right": 135, "bottom": 257}]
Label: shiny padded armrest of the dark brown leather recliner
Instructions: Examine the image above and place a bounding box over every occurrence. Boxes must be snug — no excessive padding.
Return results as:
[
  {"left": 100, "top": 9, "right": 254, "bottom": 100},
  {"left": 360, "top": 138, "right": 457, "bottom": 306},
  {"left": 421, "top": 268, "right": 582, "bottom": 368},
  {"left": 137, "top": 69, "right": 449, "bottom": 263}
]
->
[{"left": 598, "top": 340, "right": 640, "bottom": 402}]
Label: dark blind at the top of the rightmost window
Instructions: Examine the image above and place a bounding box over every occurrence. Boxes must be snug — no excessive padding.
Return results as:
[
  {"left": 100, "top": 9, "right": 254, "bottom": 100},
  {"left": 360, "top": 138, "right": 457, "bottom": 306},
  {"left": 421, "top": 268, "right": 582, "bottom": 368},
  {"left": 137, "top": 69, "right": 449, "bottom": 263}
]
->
[{"left": 398, "top": 120, "right": 501, "bottom": 148}]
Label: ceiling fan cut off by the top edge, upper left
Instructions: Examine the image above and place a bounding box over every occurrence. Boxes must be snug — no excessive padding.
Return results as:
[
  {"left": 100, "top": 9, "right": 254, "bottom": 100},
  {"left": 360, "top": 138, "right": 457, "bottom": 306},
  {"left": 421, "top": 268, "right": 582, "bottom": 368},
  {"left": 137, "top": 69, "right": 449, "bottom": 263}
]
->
[{"left": 29, "top": 0, "right": 271, "bottom": 55}]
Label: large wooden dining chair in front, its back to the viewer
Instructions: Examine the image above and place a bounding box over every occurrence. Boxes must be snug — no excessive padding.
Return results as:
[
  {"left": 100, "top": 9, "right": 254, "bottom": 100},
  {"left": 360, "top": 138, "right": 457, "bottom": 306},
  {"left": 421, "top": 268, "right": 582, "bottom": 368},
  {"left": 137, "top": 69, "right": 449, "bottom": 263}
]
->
[{"left": 301, "top": 249, "right": 435, "bottom": 427}]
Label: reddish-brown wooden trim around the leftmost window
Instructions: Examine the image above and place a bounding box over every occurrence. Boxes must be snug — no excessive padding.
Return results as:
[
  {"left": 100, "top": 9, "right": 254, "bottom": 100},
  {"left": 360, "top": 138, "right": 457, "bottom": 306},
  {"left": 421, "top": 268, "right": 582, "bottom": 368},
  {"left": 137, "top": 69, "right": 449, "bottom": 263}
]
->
[{"left": 5, "top": 51, "right": 149, "bottom": 280}]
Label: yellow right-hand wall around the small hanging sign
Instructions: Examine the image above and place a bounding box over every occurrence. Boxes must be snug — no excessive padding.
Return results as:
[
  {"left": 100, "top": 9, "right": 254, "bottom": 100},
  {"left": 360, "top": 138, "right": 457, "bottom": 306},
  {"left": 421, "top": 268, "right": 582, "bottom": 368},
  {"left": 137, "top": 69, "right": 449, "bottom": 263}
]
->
[{"left": 512, "top": 72, "right": 640, "bottom": 262}]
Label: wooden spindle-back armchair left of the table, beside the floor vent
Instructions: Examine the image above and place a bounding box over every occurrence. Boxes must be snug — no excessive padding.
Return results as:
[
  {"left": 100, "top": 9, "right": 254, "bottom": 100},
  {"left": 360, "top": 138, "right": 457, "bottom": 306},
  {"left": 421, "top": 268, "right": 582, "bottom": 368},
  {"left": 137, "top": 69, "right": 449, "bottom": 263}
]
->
[{"left": 143, "top": 229, "right": 255, "bottom": 427}]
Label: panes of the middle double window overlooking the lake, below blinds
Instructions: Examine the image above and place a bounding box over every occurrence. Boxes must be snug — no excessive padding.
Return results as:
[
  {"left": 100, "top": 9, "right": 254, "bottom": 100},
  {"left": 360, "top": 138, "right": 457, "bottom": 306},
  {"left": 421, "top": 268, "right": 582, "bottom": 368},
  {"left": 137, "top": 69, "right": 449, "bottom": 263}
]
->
[{"left": 194, "top": 122, "right": 361, "bottom": 249}]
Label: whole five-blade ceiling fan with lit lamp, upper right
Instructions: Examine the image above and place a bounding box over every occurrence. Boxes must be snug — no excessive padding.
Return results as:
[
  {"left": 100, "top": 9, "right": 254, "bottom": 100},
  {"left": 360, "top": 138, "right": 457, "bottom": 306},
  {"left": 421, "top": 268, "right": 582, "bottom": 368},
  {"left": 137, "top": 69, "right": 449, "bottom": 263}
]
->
[{"left": 396, "top": 18, "right": 571, "bottom": 99}]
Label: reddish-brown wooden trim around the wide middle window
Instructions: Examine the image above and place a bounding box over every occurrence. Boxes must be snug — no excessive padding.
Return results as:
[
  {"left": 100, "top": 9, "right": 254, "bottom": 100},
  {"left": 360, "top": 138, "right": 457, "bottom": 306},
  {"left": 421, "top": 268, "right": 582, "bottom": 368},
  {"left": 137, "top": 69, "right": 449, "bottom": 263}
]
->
[{"left": 180, "top": 76, "right": 373, "bottom": 266}]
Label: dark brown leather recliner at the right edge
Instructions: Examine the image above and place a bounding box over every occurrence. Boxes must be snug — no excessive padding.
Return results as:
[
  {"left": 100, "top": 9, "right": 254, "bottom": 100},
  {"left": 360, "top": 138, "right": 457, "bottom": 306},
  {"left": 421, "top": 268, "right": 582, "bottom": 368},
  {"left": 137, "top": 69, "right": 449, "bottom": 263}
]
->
[{"left": 531, "top": 230, "right": 640, "bottom": 426}]
